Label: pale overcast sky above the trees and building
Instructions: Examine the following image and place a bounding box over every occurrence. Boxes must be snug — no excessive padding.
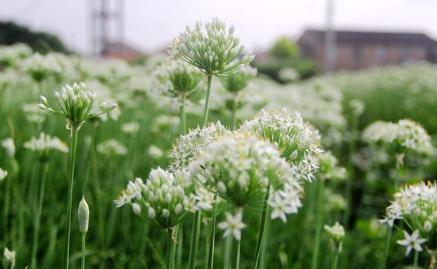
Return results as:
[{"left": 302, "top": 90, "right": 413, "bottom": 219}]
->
[{"left": 0, "top": 0, "right": 437, "bottom": 52}]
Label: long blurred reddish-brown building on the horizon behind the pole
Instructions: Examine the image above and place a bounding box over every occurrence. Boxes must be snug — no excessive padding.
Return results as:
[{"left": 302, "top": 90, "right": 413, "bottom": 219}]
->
[{"left": 298, "top": 30, "right": 437, "bottom": 70}]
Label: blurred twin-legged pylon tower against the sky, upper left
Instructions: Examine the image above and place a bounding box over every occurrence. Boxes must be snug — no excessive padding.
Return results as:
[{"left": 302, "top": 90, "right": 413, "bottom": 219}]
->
[{"left": 89, "top": 0, "right": 124, "bottom": 57}]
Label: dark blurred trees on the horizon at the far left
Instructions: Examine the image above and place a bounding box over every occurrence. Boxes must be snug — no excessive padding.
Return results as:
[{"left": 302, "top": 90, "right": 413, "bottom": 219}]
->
[{"left": 0, "top": 22, "right": 71, "bottom": 53}]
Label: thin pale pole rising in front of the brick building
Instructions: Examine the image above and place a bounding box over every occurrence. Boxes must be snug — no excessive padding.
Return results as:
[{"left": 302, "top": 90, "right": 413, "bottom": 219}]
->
[{"left": 324, "top": 0, "right": 337, "bottom": 72}]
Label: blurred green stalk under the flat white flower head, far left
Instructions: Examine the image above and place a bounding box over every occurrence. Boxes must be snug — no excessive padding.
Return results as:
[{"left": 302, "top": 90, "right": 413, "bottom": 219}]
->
[{"left": 30, "top": 160, "right": 49, "bottom": 269}]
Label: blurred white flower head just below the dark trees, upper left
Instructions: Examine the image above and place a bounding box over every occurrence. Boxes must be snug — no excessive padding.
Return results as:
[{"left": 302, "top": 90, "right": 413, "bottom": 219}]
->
[{"left": 20, "top": 53, "right": 62, "bottom": 82}]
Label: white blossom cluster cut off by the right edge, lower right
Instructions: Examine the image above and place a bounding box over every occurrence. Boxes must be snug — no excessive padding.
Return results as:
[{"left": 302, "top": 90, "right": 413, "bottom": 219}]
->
[{"left": 382, "top": 182, "right": 437, "bottom": 230}]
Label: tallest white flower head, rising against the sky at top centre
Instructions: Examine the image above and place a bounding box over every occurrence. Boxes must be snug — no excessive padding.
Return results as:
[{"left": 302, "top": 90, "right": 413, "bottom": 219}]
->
[{"left": 171, "top": 19, "right": 254, "bottom": 76}]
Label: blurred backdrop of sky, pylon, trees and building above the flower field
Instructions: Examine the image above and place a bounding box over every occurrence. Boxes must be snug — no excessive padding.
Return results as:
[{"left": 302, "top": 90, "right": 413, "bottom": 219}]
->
[{"left": 0, "top": 0, "right": 437, "bottom": 79}]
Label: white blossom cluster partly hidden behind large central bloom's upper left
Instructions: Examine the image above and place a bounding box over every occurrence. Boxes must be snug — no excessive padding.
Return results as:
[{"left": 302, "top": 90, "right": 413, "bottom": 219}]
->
[{"left": 170, "top": 122, "right": 230, "bottom": 170}]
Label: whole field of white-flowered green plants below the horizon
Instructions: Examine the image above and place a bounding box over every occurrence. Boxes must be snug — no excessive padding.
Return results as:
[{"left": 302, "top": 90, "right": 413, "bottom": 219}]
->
[{"left": 0, "top": 20, "right": 437, "bottom": 269}]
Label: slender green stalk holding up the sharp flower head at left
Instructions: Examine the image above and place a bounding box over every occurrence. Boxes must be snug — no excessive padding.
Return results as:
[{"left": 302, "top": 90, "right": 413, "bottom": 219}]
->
[{"left": 64, "top": 125, "right": 78, "bottom": 269}]
